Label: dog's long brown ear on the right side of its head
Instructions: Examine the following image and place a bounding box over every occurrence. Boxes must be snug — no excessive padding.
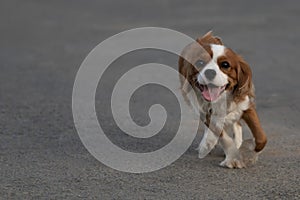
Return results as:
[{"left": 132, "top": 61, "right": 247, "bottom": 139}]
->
[{"left": 234, "top": 57, "right": 254, "bottom": 99}]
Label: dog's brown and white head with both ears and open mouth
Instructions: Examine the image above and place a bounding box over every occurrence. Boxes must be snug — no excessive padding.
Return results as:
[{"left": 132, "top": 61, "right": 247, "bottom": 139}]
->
[{"left": 179, "top": 32, "right": 253, "bottom": 102}]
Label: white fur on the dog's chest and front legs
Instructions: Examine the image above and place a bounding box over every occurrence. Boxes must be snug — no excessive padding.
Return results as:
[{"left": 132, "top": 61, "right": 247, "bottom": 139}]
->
[{"left": 198, "top": 93, "right": 250, "bottom": 168}]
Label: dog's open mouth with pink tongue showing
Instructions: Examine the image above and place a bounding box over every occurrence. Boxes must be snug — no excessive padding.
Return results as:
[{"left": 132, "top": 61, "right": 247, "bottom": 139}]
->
[{"left": 198, "top": 83, "right": 226, "bottom": 101}]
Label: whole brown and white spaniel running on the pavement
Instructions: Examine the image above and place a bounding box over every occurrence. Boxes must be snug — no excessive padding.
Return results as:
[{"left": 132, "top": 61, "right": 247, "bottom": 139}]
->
[{"left": 178, "top": 31, "right": 267, "bottom": 168}]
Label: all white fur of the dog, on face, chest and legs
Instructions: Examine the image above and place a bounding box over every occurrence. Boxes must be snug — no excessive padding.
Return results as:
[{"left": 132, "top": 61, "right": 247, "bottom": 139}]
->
[{"left": 184, "top": 44, "right": 251, "bottom": 168}]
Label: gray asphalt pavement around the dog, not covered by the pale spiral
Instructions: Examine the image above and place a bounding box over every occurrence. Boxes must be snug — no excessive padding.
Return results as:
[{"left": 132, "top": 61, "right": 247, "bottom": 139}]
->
[{"left": 0, "top": 0, "right": 300, "bottom": 199}]
